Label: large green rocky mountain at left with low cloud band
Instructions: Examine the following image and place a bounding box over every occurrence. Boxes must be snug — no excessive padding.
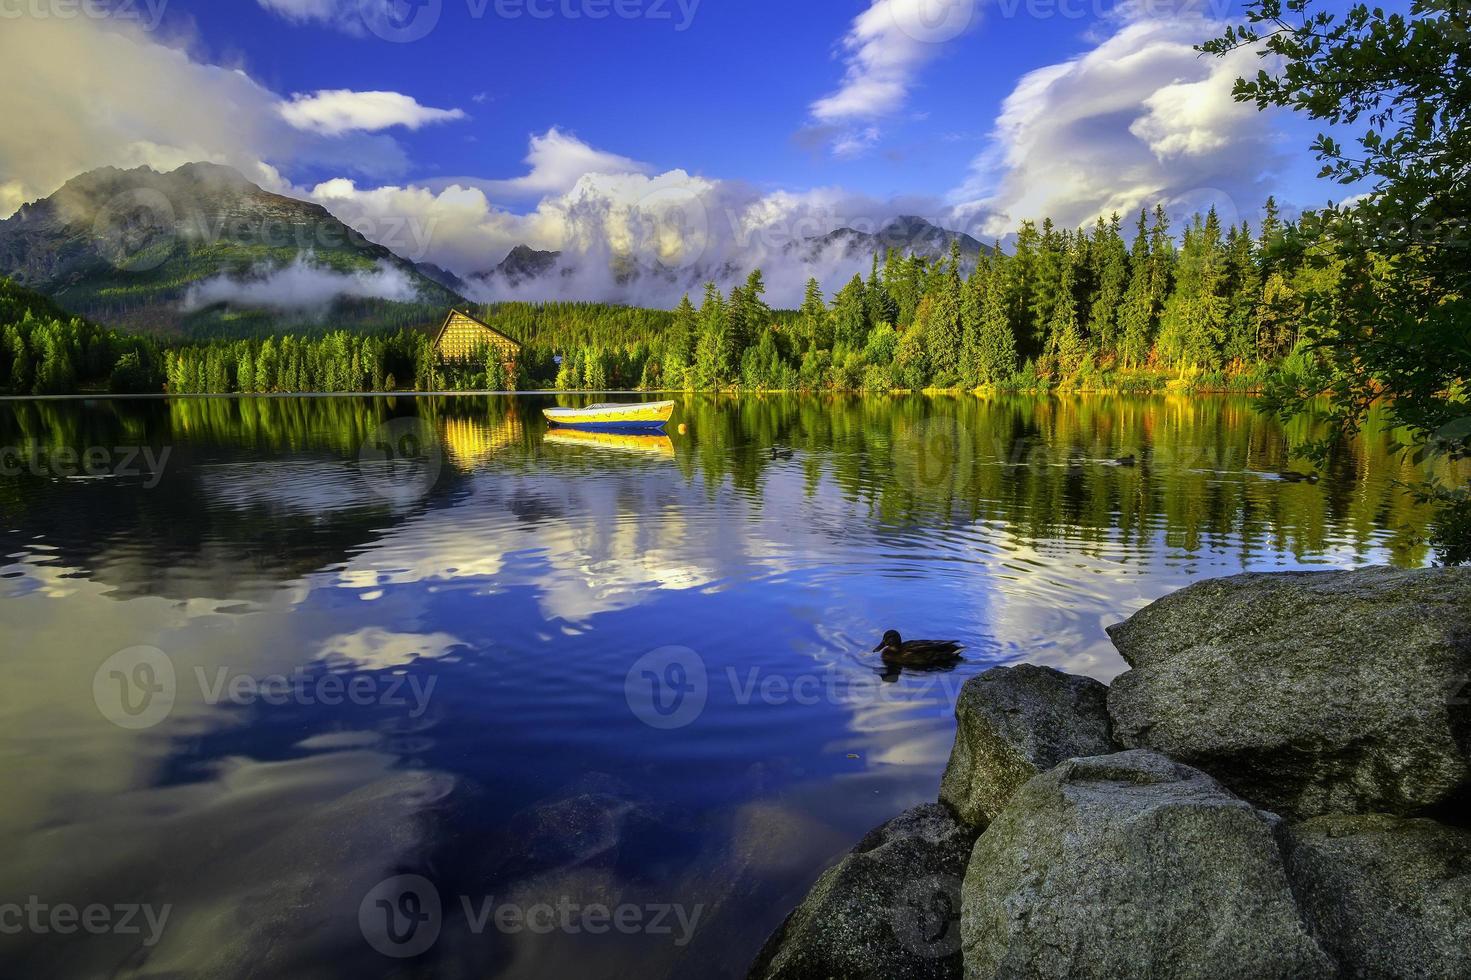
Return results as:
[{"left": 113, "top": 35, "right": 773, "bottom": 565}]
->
[{"left": 0, "top": 163, "right": 462, "bottom": 335}]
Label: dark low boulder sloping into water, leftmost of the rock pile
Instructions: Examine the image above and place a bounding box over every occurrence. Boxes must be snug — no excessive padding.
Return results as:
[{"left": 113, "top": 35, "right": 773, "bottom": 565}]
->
[{"left": 749, "top": 803, "right": 975, "bottom": 980}]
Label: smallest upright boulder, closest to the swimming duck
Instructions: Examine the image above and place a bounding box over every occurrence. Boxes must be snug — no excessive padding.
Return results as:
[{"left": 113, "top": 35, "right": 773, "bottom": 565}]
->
[{"left": 940, "top": 664, "right": 1116, "bottom": 828}]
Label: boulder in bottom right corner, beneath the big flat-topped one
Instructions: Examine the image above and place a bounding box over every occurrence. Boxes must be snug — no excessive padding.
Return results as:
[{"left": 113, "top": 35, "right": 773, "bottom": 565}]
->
[{"left": 1287, "top": 814, "right": 1471, "bottom": 979}]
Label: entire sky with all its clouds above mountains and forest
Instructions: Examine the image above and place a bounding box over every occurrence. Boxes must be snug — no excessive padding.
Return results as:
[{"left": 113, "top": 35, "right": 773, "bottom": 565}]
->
[{"left": 0, "top": 0, "right": 1353, "bottom": 302}]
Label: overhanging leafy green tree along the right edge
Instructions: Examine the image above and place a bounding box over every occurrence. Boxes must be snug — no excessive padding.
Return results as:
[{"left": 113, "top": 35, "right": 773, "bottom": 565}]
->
[{"left": 1202, "top": 0, "right": 1471, "bottom": 562}]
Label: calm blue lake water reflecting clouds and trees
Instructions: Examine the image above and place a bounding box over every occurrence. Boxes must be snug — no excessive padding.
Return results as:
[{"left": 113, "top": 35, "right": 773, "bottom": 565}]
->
[{"left": 0, "top": 396, "right": 1431, "bottom": 979}]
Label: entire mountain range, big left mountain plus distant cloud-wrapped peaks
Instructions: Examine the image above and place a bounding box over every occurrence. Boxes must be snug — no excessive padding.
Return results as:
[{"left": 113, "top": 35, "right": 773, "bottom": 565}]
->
[{"left": 0, "top": 163, "right": 990, "bottom": 337}]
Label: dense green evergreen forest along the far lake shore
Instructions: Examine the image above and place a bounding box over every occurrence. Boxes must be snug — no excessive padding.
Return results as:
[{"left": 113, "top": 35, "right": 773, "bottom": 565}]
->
[{"left": 0, "top": 200, "right": 1336, "bottom": 394}]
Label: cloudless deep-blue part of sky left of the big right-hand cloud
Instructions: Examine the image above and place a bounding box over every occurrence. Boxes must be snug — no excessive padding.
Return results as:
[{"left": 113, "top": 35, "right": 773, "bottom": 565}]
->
[{"left": 155, "top": 0, "right": 1096, "bottom": 197}]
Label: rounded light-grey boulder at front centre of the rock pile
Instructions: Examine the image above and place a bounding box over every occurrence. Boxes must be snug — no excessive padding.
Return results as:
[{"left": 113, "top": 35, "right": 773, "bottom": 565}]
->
[{"left": 961, "top": 750, "right": 1333, "bottom": 980}]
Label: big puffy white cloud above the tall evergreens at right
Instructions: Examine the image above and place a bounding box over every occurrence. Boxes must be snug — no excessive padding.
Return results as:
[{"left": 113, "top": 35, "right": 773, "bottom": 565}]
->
[{"left": 952, "top": 15, "right": 1281, "bottom": 235}]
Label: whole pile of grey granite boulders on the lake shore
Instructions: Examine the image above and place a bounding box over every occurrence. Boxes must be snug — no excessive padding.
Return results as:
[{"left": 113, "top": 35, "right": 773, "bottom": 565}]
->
[{"left": 747, "top": 565, "right": 1471, "bottom": 980}]
